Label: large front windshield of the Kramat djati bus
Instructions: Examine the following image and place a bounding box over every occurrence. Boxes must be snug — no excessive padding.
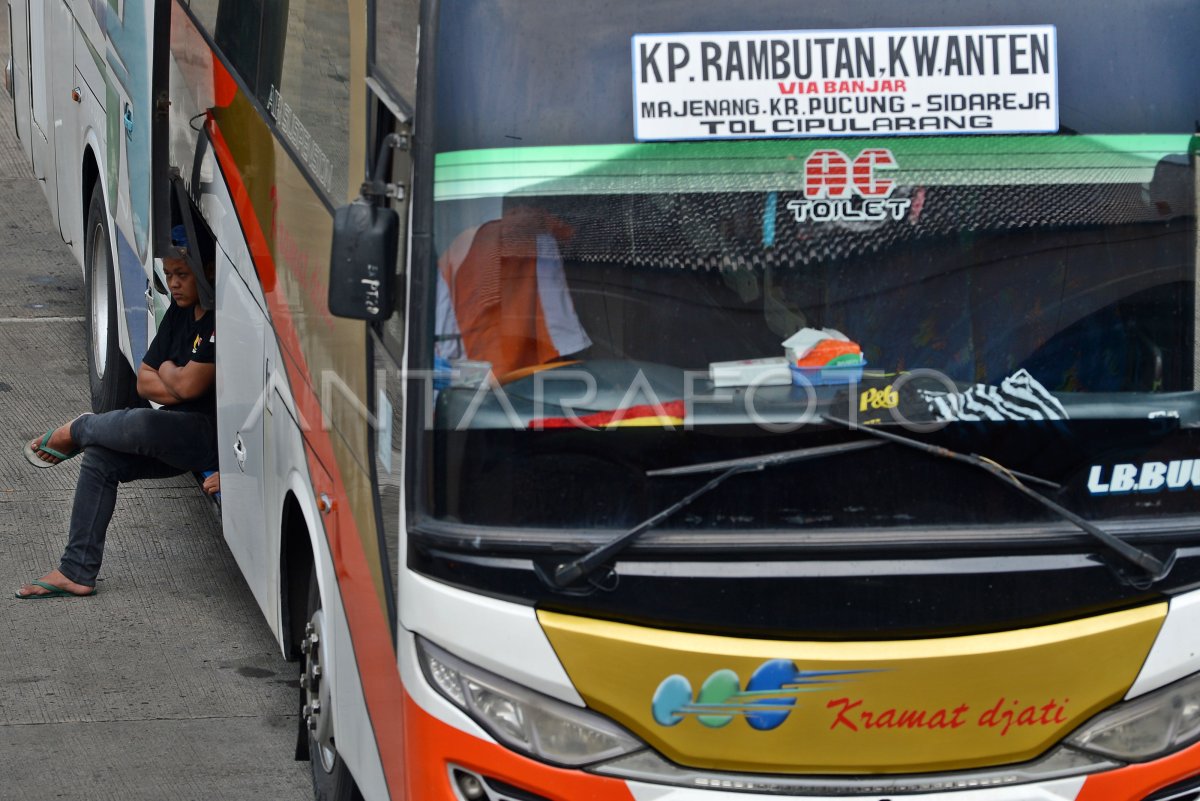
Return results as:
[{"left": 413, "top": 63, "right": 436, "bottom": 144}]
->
[{"left": 412, "top": 0, "right": 1200, "bottom": 531}]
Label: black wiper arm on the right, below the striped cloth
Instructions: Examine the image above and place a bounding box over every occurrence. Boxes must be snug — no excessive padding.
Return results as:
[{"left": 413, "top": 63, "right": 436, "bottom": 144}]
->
[{"left": 822, "top": 415, "right": 1178, "bottom": 589}]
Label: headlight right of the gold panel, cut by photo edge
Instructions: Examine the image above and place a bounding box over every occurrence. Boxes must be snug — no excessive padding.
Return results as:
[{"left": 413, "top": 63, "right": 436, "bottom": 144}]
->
[{"left": 1067, "top": 673, "right": 1200, "bottom": 761}]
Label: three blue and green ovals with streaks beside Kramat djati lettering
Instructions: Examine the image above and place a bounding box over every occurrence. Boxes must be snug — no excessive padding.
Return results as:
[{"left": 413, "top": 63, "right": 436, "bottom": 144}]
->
[{"left": 650, "top": 660, "right": 878, "bottom": 731}]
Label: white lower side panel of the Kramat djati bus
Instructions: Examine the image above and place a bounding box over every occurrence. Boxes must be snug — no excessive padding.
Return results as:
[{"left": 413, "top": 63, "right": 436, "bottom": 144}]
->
[{"left": 202, "top": 165, "right": 388, "bottom": 799}]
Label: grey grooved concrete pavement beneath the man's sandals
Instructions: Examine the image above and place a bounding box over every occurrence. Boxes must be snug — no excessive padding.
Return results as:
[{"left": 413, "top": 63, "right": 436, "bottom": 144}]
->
[{"left": 0, "top": 7, "right": 311, "bottom": 801}]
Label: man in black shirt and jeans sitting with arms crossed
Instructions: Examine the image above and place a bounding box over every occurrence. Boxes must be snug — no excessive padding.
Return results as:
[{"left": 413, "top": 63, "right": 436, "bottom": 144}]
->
[{"left": 17, "top": 227, "right": 220, "bottom": 600}]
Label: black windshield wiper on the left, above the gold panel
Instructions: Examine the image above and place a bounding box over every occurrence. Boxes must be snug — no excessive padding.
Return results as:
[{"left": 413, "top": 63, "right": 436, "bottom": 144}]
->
[{"left": 536, "top": 440, "right": 883, "bottom": 589}]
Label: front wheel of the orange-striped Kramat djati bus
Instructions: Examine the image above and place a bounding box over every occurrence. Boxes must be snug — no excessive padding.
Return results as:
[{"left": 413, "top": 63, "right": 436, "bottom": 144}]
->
[{"left": 300, "top": 571, "right": 361, "bottom": 801}]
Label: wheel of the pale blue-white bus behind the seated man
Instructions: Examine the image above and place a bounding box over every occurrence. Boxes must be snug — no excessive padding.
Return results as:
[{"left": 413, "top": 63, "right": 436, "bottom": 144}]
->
[{"left": 83, "top": 181, "right": 134, "bottom": 411}]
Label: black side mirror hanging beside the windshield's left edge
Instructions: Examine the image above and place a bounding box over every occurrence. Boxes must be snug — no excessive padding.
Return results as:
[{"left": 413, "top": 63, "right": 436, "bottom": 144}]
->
[{"left": 329, "top": 198, "right": 400, "bottom": 321}]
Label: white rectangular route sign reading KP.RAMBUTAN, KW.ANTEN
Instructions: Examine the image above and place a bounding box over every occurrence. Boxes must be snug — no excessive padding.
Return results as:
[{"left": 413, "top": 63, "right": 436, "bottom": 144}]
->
[{"left": 632, "top": 25, "right": 1058, "bottom": 141}]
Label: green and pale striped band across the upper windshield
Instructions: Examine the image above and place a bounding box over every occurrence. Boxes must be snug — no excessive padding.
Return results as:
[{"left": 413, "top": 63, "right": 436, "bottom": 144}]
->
[{"left": 434, "top": 134, "right": 1193, "bottom": 200}]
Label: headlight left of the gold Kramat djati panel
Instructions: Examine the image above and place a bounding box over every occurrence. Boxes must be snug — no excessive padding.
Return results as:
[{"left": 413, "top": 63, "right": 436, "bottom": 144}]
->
[{"left": 416, "top": 637, "right": 646, "bottom": 767}]
